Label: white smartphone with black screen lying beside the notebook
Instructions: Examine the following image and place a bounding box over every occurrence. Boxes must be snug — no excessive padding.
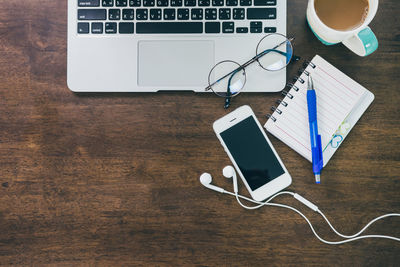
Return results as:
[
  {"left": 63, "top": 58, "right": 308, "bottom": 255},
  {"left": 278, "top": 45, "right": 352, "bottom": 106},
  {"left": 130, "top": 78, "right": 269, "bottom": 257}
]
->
[{"left": 213, "top": 106, "right": 292, "bottom": 201}]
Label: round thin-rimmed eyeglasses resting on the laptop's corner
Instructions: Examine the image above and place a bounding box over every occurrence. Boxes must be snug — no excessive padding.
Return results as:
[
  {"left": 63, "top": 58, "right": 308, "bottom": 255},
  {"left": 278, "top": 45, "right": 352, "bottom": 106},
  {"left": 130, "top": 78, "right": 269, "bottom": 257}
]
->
[{"left": 205, "top": 33, "right": 299, "bottom": 108}]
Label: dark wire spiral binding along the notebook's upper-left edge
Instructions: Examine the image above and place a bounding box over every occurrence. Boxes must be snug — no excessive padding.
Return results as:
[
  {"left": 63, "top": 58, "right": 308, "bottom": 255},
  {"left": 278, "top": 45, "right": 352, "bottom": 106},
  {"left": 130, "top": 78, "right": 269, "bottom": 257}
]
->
[{"left": 266, "top": 61, "right": 316, "bottom": 122}]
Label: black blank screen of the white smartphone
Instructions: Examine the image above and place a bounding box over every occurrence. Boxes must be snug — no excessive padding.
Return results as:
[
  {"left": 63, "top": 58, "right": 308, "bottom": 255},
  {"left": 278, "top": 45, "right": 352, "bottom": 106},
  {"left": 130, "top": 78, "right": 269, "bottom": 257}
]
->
[{"left": 221, "top": 116, "right": 285, "bottom": 191}]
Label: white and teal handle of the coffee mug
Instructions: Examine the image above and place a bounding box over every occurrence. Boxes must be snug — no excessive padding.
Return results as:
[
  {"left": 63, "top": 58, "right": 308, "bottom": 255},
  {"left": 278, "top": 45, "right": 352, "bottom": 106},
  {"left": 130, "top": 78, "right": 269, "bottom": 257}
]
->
[{"left": 343, "top": 27, "right": 378, "bottom": 57}]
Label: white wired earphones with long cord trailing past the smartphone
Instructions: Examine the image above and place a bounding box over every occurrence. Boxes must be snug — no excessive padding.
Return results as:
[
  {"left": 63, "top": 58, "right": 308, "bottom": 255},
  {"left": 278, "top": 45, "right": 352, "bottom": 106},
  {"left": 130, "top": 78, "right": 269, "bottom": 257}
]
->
[{"left": 200, "top": 166, "right": 400, "bottom": 245}]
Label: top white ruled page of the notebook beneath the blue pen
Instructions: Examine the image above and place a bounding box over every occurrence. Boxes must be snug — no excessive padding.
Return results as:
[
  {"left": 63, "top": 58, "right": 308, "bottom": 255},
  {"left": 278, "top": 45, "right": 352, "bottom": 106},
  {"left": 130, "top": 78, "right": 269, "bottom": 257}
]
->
[{"left": 264, "top": 55, "right": 367, "bottom": 161}]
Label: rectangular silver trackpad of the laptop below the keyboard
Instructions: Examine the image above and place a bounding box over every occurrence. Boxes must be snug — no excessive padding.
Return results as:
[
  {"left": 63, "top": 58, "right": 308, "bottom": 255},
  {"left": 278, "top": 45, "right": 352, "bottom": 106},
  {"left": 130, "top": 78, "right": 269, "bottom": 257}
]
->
[{"left": 138, "top": 41, "right": 214, "bottom": 89}]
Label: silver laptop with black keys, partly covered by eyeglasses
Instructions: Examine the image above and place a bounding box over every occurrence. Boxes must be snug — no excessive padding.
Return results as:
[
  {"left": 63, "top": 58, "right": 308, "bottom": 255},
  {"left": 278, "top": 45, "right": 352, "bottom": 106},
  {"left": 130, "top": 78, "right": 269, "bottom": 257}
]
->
[{"left": 67, "top": 0, "right": 286, "bottom": 92}]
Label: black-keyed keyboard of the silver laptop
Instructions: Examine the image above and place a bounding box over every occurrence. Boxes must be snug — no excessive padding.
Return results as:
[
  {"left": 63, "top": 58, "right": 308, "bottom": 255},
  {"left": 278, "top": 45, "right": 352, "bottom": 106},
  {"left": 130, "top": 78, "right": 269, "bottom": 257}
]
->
[{"left": 77, "top": 0, "right": 279, "bottom": 35}]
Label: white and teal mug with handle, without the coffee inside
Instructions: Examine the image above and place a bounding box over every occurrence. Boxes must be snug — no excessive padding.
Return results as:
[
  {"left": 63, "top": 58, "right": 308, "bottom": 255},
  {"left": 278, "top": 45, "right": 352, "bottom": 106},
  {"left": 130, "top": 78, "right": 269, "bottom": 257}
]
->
[{"left": 307, "top": 0, "right": 379, "bottom": 56}]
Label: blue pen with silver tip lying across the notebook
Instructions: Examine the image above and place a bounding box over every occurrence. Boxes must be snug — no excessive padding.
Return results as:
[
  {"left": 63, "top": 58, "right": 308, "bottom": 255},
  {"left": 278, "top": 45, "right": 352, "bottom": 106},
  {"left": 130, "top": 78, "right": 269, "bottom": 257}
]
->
[{"left": 307, "top": 74, "right": 324, "bottom": 184}]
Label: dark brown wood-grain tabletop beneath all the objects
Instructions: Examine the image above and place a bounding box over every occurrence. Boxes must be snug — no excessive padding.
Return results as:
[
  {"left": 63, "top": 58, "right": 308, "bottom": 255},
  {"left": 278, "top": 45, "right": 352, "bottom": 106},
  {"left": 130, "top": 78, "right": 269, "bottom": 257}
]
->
[{"left": 0, "top": 0, "right": 400, "bottom": 266}]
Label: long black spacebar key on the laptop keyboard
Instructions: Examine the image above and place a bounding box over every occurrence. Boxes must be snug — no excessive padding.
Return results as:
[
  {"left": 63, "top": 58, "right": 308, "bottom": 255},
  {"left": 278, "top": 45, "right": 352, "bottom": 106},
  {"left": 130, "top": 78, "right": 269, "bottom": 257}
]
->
[{"left": 136, "top": 22, "right": 203, "bottom": 34}]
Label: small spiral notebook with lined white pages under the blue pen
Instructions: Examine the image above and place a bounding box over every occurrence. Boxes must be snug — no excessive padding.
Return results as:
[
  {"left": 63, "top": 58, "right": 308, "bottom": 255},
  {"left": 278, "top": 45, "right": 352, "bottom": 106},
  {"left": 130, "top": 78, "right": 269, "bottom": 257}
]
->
[{"left": 264, "top": 55, "right": 374, "bottom": 166}]
